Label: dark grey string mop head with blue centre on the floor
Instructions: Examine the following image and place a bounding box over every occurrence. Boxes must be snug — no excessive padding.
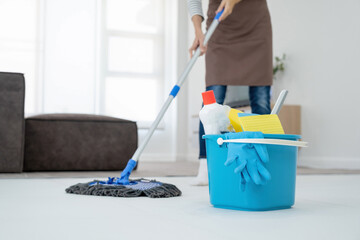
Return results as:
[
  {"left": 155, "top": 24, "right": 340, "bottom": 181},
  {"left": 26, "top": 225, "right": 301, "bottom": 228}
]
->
[{"left": 65, "top": 177, "right": 181, "bottom": 198}]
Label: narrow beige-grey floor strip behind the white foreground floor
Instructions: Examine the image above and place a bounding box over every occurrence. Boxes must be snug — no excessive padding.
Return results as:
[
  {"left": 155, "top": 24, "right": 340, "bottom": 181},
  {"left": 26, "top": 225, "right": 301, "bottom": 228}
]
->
[{"left": 0, "top": 161, "right": 360, "bottom": 179}]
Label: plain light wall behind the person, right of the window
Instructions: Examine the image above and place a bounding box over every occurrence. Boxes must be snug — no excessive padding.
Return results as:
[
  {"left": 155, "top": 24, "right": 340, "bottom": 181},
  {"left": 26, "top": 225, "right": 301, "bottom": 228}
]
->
[{"left": 188, "top": 0, "right": 360, "bottom": 168}]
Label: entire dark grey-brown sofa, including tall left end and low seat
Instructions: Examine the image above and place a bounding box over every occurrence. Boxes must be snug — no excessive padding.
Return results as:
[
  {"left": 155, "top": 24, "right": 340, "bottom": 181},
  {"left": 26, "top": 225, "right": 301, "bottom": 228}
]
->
[{"left": 0, "top": 72, "right": 138, "bottom": 173}]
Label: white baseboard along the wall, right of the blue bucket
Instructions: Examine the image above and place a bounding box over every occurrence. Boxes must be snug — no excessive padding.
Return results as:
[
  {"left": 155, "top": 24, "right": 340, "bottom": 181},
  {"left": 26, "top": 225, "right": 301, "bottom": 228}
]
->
[{"left": 298, "top": 157, "right": 360, "bottom": 170}]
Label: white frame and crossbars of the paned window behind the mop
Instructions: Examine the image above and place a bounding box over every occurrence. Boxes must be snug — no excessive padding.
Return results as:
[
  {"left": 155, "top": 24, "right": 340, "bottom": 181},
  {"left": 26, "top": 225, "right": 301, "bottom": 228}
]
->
[{"left": 96, "top": 0, "right": 177, "bottom": 129}]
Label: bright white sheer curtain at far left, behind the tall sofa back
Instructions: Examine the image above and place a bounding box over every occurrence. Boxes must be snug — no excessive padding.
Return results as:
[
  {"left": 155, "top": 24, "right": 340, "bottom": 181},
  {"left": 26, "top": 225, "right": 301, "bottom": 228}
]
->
[{"left": 0, "top": 0, "right": 39, "bottom": 112}]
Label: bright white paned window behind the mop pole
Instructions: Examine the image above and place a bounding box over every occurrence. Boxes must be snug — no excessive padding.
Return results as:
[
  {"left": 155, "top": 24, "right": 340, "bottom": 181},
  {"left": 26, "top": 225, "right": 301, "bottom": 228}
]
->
[{"left": 100, "top": 0, "right": 164, "bottom": 122}]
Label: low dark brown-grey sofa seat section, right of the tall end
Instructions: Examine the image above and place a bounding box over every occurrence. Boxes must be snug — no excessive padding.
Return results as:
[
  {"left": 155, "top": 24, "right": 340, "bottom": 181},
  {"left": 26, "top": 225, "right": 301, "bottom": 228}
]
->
[{"left": 24, "top": 114, "right": 138, "bottom": 171}]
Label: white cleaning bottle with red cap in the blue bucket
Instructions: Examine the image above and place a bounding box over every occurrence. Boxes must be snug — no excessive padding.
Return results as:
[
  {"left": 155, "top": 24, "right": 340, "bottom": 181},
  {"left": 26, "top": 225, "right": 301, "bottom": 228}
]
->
[{"left": 199, "top": 90, "right": 230, "bottom": 135}]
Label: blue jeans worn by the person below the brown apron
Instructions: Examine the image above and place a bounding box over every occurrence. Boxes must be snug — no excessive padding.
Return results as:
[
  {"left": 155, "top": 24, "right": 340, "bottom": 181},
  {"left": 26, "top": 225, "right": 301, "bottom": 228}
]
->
[{"left": 199, "top": 85, "right": 271, "bottom": 158}]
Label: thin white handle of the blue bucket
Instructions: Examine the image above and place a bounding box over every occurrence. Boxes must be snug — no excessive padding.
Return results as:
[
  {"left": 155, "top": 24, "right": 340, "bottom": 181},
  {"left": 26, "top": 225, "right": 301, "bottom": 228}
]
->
[{"left": 217, "top": 138, "right": 308, "bottom": 147}]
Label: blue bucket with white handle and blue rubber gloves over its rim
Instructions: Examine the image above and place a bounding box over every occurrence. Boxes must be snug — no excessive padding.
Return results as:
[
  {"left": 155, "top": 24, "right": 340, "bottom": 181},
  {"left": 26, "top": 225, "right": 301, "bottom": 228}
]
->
[{"left": 203, "top": 133, "right": 306, "bottom": 211}]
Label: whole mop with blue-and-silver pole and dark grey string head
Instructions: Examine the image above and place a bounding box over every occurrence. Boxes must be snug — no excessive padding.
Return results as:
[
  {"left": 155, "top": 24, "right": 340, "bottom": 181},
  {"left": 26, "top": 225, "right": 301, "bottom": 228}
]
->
[{"left": 65, "top": 10, "right": 224, "bottom": 198}]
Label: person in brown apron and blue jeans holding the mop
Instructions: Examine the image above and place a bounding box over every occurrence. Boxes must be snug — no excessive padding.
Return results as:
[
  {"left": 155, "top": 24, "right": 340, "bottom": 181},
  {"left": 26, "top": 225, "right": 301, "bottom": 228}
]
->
[{"left": 188, "top": 0, "right": 272, "bottom": 185}]
